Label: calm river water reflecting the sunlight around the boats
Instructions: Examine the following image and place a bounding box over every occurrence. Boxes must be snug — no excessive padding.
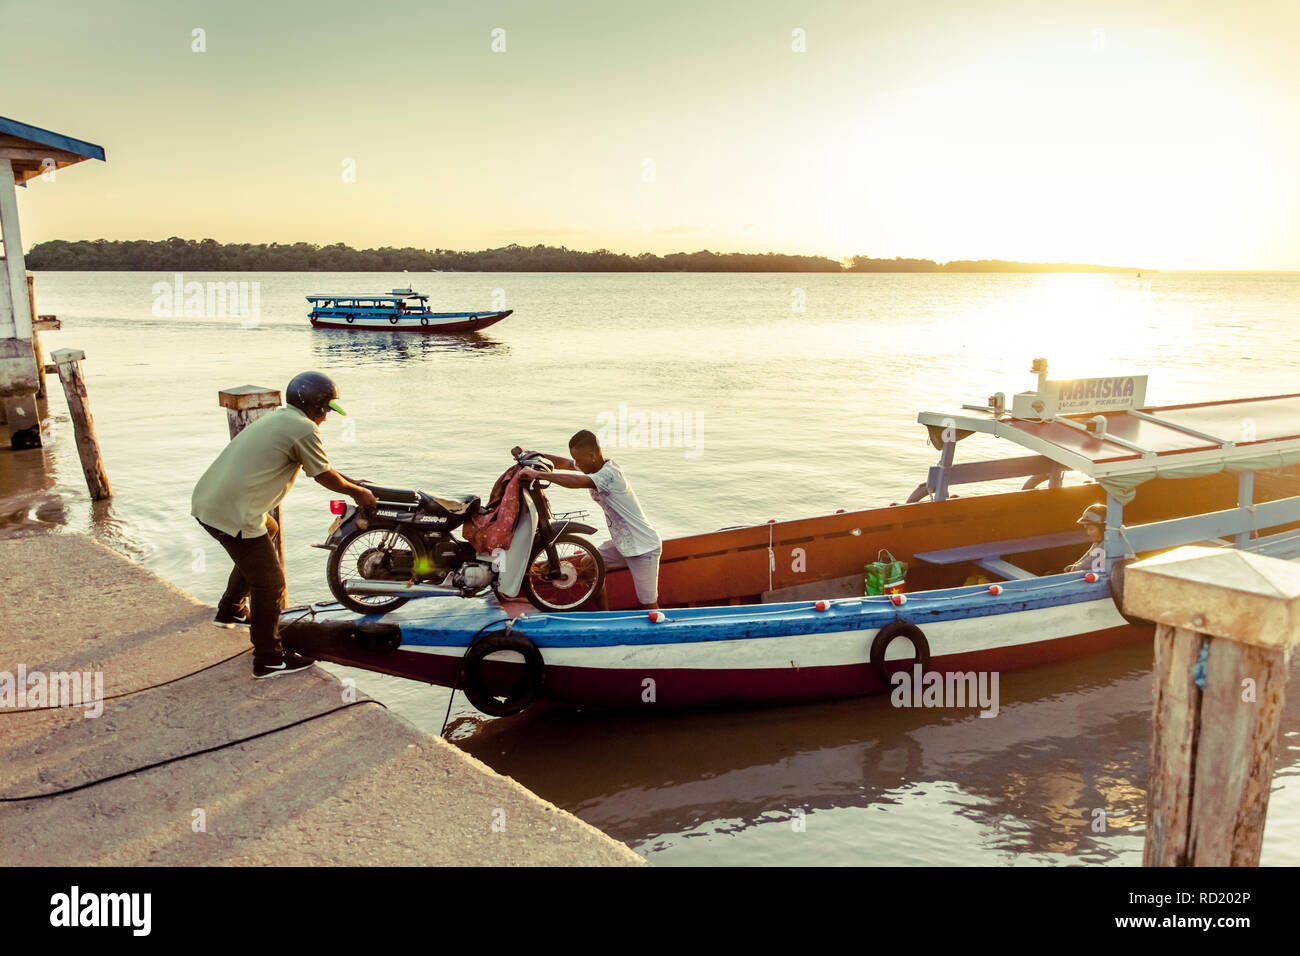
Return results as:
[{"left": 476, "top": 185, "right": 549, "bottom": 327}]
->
[{"left": 0, "top": 273, "right": 1300, "bottom": 865}]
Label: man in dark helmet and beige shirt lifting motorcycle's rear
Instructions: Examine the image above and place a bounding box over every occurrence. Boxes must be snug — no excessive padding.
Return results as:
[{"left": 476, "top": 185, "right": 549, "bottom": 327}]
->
[{"left": 190, "top": 372, "right": 376, "bottom": 679}]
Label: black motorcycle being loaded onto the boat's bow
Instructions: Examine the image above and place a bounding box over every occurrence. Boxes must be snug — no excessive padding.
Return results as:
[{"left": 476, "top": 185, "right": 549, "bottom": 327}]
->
[{"left": 322, "top": 451, "right": 605, "bottom": 614}]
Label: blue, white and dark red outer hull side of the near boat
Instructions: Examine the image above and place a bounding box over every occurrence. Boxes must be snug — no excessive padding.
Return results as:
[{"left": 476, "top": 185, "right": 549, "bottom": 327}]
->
[{"left": 285, "top": 574, "right": 1151, "bottom": 710}]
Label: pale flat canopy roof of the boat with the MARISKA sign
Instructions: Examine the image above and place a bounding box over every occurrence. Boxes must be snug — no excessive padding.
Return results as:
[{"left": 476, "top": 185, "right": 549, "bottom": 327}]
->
[{"left": 917, "top": 390, "right": 1300, "bottom": 503}]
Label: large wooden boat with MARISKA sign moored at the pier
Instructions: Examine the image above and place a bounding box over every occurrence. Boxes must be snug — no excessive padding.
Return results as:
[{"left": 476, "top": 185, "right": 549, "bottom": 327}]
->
[{"left": 282, "top": 360, "right": 1300, "bottom": 713}]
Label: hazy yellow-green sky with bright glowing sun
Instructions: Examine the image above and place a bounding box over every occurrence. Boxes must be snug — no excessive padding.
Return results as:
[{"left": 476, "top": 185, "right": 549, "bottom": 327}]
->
[{"left": 0, "top": 0, "right": 1300, "bottom": 269}]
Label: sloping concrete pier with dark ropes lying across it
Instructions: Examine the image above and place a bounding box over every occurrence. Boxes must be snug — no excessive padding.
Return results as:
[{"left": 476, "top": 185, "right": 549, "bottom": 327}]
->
[{"left": 0, "top": 535, "right": 644, "bottom": 866}]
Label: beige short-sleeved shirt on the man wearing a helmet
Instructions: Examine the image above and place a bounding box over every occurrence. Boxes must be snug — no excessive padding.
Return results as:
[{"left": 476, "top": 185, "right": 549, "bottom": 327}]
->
[{"left": 190, "top": 405, "right": 330, "bottom": 537}]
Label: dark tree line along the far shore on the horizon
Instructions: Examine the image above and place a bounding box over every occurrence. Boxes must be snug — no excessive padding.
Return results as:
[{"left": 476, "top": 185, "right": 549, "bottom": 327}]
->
[{"left": 27, "top": 235, "right": 1149, "bottom": 272}]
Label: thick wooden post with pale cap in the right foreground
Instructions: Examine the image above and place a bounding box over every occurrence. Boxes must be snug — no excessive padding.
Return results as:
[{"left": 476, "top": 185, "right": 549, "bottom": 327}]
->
[{"left": 1125, "top": 548, "right": 1300, "bottom": 866}]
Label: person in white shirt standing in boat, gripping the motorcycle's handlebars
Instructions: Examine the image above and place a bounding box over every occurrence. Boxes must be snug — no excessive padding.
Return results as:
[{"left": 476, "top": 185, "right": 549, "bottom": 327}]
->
[{"left": 511, "top": 429, "right": 663, "bottom": 609}]
